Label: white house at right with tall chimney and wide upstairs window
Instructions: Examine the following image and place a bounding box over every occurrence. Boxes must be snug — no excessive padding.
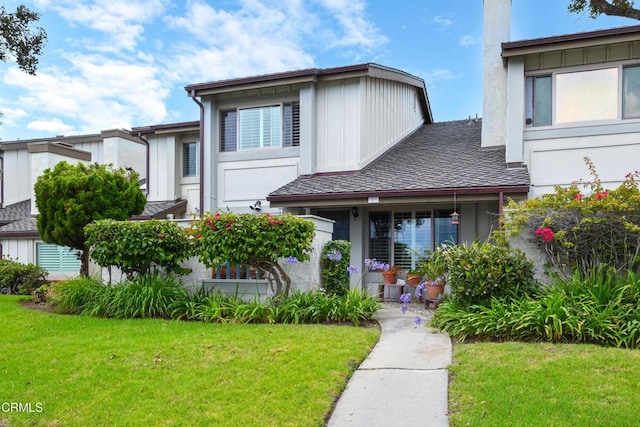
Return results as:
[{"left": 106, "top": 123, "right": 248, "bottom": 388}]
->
[{"left": 482, "top": 0, "right": 640, "bottom": 197}]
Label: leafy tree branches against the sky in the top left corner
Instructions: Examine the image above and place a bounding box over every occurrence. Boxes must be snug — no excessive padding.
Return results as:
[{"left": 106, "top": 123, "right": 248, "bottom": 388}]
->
[{"left": 0, "top": 5, "right": 47, "bottom": 75}]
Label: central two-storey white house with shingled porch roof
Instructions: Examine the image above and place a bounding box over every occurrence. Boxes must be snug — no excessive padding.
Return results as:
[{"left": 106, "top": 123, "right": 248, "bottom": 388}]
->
[{"left": 186, "top": 64, "right": 529, "bottom": 290}]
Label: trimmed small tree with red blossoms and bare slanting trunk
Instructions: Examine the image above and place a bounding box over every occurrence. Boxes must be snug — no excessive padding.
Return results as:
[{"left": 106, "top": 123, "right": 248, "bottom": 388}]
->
[{"left": 190, "top": 212, "right": 315, "bottom": 296}]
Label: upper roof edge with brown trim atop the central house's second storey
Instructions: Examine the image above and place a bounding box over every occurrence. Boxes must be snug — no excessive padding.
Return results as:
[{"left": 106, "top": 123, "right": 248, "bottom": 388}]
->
[{"left": 185, "top": 63, "right": 433, "bottom": 123}]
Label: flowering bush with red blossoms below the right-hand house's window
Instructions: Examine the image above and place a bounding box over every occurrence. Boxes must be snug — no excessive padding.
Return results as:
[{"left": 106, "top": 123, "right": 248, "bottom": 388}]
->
[{"left": 503, "top": 158, "right": 640, "bottom": 276}]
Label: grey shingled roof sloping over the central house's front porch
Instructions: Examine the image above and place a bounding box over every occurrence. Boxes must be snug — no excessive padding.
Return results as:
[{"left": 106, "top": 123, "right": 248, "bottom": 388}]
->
[{"left": 268, "top": 120, "right": 529, "bottom": 204}]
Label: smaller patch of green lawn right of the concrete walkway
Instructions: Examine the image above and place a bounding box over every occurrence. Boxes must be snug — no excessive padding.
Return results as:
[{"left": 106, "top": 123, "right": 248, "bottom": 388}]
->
[{"left": 449, "top": 342, "right": 640, "bottom": 427}]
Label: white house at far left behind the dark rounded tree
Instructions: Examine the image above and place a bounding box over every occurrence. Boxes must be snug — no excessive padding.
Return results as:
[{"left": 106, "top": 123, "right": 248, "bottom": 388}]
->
[{"left": 0, "top": 130, "right": 187, "bottom": 279}]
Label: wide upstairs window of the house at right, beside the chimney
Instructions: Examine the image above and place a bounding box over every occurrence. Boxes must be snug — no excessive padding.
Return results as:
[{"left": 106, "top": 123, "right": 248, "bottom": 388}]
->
[{"left": 525, "top": 66, "right": 640, "bottom": 127}]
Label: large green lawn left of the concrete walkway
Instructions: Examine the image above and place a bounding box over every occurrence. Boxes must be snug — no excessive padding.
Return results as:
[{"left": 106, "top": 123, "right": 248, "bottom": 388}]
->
[{"left": 0, "top": 296, "right": 379, "bottom": 426}]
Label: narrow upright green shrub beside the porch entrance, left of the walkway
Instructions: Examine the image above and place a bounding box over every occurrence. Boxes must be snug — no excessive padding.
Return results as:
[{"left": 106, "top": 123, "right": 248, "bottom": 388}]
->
[{"left": 320, "top": 240, "right": 351, "bottom": 295}]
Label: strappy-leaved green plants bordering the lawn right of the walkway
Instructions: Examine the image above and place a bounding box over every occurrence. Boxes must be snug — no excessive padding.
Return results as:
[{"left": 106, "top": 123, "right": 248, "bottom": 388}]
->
[{"left": 432, "top": 266, "right": 640, "bottom": 348}]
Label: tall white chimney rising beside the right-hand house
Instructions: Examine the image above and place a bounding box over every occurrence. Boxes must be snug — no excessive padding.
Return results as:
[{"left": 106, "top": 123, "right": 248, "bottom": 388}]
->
[{"left": 482, "top": 0, "right": 511, "bottom": 147}]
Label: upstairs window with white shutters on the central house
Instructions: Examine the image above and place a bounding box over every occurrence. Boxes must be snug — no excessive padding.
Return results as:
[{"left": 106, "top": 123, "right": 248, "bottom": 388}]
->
[{"left": 220, "top": 102, "right": 300, "bottom": 151}]
